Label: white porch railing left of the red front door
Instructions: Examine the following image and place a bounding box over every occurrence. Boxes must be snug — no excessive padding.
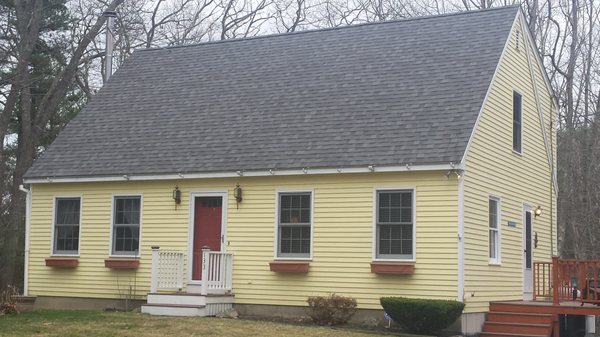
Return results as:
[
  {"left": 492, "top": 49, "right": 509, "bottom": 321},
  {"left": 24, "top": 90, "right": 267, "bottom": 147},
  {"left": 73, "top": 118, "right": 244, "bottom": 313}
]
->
[{"left": 150, "top": 246, "right": 183, "bottom": 293}]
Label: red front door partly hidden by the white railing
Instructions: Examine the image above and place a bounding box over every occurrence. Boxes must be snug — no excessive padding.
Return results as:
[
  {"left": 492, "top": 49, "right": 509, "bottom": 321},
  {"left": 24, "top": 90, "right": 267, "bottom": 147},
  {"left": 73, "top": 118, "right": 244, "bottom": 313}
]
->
[{"left": 192, "top": 197, "right": 223, "bottom": 280}]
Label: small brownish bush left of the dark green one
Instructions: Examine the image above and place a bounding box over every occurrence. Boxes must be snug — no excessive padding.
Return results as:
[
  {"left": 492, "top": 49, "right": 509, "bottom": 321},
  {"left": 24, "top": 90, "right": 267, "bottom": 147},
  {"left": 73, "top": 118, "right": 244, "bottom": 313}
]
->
[{"left": 307, "top": 294, "right": 356, "bottom": 325}]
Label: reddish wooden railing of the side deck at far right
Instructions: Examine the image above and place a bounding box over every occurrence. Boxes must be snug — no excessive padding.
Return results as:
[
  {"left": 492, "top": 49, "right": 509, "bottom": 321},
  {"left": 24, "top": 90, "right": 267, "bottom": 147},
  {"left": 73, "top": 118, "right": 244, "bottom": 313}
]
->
[{"left": 533, "top": 257, "right": 600, "bottom": 304}]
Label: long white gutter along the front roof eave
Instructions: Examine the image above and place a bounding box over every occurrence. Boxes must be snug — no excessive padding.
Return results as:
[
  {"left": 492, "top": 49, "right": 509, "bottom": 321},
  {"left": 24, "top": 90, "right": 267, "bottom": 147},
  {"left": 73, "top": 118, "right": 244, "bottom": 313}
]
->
[{"left": 24, "top": 163, "right": 462, "bottom": 184}]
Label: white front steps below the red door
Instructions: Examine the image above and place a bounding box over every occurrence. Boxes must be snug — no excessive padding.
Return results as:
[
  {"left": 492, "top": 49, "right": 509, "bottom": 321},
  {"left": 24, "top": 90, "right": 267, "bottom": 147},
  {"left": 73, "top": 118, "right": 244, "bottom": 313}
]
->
[{"left": 142, "top": 293, "right": 233, "bottom": 316}]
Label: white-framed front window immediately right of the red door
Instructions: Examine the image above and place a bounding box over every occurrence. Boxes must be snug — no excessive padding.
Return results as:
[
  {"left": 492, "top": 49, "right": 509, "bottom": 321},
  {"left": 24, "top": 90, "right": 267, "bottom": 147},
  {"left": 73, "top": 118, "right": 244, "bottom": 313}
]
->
[{"left": 277, "top": 192, "right": 312, "bottom": 259}]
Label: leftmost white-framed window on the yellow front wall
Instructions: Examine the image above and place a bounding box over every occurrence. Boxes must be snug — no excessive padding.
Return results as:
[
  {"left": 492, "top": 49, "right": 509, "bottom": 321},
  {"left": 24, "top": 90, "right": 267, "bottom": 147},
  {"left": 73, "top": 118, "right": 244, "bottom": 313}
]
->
[{"left": 52, "top": 197, "right": 81, "bottom": 255}]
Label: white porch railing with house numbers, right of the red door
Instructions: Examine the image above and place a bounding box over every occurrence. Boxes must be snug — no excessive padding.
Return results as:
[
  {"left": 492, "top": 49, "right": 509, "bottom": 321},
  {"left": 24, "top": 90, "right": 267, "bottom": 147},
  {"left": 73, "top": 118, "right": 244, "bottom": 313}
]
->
[{"left": 200, "top": 247, "right": 233, "bottom": 295}]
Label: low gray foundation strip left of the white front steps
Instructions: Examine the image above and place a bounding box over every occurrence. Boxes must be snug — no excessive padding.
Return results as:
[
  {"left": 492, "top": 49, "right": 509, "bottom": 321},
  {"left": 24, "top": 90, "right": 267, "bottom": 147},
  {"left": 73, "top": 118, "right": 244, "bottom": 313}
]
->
[{"left": 33, "top": 296, "right": 146, "bottom": 311}]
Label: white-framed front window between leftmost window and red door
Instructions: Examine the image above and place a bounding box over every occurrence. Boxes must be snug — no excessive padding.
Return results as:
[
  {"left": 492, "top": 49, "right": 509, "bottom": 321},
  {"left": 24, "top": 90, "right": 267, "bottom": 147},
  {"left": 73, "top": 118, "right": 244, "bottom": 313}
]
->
[{"left": 111, "top": 195, "right": 142, "bottom": 255}]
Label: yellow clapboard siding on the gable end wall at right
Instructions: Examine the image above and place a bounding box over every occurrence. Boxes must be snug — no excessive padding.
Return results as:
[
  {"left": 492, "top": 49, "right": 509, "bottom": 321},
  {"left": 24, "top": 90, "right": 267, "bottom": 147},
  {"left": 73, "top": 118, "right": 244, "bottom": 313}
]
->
[{"left": 464, "top": 18, "right": 556, "bottom": 312}]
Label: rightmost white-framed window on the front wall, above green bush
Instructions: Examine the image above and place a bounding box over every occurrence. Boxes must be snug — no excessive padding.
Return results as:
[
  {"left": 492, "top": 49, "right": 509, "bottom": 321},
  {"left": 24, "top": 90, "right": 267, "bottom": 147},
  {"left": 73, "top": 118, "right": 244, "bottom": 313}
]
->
[{"left": 375, "top": 189, "right": 415, "bottom": 260}]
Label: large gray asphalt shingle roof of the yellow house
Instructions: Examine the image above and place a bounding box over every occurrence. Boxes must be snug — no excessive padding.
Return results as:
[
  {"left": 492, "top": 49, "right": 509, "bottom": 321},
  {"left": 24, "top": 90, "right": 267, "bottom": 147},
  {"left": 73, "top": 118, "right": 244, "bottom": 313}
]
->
[{"left": 26, "top": 7, "right": 518, "bottom": 178}]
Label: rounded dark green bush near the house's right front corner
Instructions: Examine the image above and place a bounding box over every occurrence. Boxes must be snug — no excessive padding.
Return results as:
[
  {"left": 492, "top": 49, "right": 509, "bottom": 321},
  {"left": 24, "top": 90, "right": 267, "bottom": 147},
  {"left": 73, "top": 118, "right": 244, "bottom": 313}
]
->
[{"left": 380, "top": 297, "right": 465, "bottom": 334}]
